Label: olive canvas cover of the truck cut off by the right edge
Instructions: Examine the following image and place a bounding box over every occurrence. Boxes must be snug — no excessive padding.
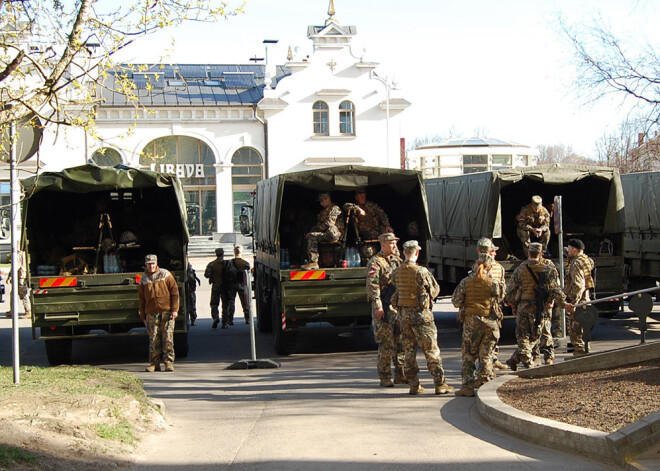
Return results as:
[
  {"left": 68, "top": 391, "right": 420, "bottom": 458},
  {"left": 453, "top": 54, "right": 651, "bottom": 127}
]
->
[{"left": 621, "top": 172, "right": 660, "bottom": 234}]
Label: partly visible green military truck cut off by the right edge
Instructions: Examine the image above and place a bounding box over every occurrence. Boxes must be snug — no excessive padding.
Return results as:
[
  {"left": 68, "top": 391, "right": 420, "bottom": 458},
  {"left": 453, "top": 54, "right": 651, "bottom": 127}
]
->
[{"left": 621, "top": 172, "right": 660, "bottom": 291}]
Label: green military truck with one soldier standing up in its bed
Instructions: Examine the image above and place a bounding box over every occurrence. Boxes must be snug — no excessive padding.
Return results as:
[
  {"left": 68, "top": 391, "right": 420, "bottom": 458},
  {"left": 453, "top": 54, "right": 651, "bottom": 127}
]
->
[{"left": 426, "top": 164, "right": 624, "bottom": 314}]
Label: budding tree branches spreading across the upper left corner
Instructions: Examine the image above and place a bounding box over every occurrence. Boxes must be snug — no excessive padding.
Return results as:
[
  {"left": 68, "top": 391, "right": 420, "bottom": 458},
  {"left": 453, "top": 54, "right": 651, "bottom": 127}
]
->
[{"left": 0, "top": 0, "right": 242, "bottom": 152}]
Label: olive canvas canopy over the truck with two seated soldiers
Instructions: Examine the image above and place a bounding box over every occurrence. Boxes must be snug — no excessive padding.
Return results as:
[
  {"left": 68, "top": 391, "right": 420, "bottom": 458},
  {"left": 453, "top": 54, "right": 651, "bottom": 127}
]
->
[{"left": 254, "top": 165, "right": 430, "bottom": 243}]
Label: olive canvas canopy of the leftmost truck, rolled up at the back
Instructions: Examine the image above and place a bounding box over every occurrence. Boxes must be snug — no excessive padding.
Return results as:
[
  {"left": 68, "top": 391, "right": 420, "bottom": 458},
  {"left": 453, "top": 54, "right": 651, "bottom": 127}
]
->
[{"left": 21, "top": 165, "right": 190, "bottom": 242}]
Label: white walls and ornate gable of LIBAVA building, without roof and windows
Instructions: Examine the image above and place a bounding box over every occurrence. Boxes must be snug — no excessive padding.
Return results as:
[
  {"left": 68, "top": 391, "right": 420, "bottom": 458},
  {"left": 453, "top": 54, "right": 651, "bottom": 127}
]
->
[{"left": 28, "top": 2, "right": 410, "bottom": 234}]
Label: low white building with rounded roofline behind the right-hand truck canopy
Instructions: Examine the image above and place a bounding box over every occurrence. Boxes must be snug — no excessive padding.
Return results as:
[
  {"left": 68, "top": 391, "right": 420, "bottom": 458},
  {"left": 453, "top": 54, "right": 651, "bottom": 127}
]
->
[{"left": 407, "top": 137, "right": 539, "bottom": 178}]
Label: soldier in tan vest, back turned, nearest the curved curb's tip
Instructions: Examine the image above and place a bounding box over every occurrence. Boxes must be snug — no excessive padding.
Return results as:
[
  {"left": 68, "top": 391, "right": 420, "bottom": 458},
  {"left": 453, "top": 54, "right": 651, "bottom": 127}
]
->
[{"left": 451, "top": 253, "right": 506, "bottom": 396}]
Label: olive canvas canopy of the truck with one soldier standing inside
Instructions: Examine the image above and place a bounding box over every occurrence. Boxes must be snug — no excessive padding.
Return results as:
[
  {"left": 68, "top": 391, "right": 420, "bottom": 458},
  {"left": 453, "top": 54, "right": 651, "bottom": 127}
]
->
[{"left": 425, "top": 164, "right": 624, "bottom": 240}]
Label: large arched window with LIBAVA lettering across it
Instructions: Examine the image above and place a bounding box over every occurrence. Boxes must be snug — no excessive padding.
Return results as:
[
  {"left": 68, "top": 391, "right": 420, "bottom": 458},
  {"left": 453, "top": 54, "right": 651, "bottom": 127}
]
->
[{"left": 140, "top": 136, "right": 216, "bottom": 235}]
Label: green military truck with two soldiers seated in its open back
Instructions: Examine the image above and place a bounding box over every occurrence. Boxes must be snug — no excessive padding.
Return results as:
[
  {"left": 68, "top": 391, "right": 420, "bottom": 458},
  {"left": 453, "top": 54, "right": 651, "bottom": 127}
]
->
[{"left": 243, "top": 166, "right": 430, "bottom": 355}]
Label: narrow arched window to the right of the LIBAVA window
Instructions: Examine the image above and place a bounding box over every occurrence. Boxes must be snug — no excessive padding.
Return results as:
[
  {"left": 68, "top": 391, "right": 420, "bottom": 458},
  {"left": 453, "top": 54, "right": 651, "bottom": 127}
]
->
[{"left": 231, "top": 147, "right": 264, "bottom": 231}]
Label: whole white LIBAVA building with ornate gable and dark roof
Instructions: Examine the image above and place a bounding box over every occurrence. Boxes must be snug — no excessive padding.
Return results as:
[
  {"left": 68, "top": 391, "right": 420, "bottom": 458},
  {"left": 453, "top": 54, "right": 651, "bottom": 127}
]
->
[{"left": 21, "top": 1, "right": 410, "bottom": 240}]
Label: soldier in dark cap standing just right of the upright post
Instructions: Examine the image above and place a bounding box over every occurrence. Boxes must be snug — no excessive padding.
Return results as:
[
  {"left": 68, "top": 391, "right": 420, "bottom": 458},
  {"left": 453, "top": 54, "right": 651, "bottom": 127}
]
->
[{"left": 564, "top": 239, "right": 594, "bottom": 355}]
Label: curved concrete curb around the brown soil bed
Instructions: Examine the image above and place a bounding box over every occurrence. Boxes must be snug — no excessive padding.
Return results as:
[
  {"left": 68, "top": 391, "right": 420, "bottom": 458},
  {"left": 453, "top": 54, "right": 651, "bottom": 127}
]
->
[{"left": 477, "top": 342, "right": 660, "bottom": 469}]
